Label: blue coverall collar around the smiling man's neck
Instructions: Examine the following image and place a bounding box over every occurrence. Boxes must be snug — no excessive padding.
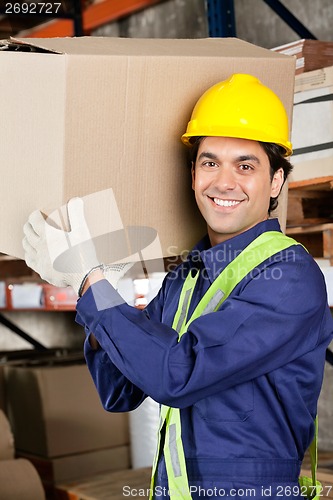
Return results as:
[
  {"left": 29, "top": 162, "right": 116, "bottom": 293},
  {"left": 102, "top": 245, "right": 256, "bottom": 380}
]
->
[{"left": 188, "top": 219, "right": 281, "bottom": 283}]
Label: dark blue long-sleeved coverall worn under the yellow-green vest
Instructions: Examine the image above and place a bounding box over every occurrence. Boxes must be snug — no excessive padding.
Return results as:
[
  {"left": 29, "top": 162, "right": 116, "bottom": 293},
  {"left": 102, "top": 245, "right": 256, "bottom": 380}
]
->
[{"left": 77, "top": 219, "right": 333, "bottom": 499}]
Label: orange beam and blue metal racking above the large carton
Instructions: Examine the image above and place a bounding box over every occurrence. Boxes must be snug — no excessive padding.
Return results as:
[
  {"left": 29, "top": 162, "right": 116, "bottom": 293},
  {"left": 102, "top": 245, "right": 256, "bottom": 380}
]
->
[{"left": 0, "top": 0, "right": 316, "bottom": 39}]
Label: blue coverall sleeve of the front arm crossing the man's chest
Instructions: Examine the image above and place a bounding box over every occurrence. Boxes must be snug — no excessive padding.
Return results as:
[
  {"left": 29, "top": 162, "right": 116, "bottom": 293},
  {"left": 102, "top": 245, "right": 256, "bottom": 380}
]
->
[{"left": 77, "top": 254, "right": 332, "bottom": 408}]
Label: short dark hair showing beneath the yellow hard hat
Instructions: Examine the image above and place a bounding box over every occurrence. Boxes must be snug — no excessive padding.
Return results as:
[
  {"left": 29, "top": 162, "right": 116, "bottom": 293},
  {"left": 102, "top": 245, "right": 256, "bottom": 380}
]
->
[{"left": 189, "top": 137, "right": 293, "bottom": 214}]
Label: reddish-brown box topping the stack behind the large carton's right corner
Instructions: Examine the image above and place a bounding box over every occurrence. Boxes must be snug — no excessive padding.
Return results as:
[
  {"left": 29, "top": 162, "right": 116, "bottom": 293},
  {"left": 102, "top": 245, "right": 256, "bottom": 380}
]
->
[{"left": 273, "top": 38, "right": 333, "bottom": 75}]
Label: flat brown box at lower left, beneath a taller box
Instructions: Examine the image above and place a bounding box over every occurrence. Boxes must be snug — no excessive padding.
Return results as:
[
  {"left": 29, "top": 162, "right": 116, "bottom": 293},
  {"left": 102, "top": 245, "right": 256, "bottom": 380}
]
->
[{"left": 18, "top": 446, "right": 130, "bottom": 486}]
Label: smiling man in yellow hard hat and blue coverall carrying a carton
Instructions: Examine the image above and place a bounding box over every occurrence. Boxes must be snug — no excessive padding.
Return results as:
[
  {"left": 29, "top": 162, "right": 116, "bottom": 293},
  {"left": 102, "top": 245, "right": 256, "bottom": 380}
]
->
[{"left": 24, "top": 75, "right": 333, "bottom": 499}]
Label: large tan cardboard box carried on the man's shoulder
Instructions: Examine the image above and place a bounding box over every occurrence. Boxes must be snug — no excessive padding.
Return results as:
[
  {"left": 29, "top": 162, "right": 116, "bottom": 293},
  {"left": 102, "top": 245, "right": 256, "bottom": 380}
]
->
[{"left": 0, "top": 37, "right": 295, "bottom": 259}]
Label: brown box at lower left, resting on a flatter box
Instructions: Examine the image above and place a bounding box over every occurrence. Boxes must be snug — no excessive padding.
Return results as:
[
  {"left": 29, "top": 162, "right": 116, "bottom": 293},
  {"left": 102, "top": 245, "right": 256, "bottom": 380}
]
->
[{"left": 5, "top": 364, "right": 129, "bottom": 458}]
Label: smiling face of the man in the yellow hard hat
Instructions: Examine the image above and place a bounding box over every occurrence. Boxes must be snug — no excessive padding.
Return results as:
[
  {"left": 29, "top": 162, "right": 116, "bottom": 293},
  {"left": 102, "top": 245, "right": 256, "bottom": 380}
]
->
[{"left": 192, "top": 137, "right": 283, "bottom": 246}]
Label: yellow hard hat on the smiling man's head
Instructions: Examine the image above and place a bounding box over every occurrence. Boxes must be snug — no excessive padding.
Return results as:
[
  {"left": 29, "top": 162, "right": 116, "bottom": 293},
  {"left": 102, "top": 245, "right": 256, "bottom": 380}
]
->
[{"left": 182, "top": 74, "right": 292, "bottom": 156}]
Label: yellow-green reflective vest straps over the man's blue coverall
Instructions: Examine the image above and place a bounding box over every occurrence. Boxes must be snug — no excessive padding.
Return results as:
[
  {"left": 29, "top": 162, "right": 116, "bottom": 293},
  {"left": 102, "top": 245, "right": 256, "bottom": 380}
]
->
[{"left": 149, "top": 231, "right": 298, "bottom": 500}]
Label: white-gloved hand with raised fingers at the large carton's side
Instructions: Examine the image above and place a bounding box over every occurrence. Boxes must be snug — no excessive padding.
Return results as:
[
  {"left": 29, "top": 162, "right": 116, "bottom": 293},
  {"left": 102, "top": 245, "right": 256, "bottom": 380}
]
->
[{"left": 23, "top": 198, "right": 100, "bottom": 293}]
